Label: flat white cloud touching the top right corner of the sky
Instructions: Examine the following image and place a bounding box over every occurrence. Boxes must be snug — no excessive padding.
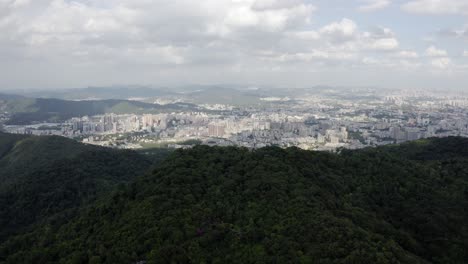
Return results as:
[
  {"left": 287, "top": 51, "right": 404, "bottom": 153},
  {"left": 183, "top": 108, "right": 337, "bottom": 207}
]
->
[{"left": 402, "top": 0, "right": 468, "bottom": 15}]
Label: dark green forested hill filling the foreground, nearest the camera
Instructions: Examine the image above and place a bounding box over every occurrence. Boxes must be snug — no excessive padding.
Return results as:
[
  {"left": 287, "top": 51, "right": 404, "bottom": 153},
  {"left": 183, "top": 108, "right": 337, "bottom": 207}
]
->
[{"left": 0, "top": 138, "right": 468, "bottom": 264}]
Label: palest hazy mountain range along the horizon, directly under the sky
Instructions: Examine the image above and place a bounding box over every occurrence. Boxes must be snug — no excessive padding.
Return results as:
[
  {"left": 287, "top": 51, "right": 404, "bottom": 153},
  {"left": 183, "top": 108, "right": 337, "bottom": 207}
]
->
[{"left": 0, "top": 85, "right": 384, "bottom": 109}]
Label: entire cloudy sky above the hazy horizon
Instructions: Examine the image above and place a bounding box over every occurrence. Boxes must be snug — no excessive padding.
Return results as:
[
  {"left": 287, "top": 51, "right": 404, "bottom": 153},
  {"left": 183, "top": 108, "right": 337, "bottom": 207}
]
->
[{"left": 0, "top": 0, "right": 468, "bottom": 90}]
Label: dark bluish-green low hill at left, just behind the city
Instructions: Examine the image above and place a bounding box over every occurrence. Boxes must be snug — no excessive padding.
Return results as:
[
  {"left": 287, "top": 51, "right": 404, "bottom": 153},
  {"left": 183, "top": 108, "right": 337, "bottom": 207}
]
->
[{"left": 3, "top": 98, "right": 196, "bottom": 125}]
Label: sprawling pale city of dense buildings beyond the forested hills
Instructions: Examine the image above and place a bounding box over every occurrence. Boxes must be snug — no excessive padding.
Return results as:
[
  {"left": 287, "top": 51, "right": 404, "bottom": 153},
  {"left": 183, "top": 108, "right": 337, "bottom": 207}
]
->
[{"left": 0, "top": 88, "right": 468, "bottom": 151}]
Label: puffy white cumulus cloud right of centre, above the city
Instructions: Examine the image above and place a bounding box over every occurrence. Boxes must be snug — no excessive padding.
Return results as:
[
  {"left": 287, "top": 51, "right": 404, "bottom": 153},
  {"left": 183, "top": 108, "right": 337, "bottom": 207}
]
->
[{"left": 262, "top": 21, "right": 402, "bottom": 67}]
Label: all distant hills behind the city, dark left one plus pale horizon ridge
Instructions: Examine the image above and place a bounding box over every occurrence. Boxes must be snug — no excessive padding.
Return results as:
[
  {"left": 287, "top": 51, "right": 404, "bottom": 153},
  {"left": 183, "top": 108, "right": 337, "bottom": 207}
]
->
[{"left": 0, "top": 86, "right": 375, "bottom": 125}]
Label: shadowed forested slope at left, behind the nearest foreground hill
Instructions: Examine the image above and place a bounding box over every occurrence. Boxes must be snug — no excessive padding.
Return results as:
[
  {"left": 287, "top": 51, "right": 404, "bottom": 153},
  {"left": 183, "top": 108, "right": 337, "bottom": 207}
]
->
[{"left": 0, "top": 133, "right": 157, "bottom": 242}]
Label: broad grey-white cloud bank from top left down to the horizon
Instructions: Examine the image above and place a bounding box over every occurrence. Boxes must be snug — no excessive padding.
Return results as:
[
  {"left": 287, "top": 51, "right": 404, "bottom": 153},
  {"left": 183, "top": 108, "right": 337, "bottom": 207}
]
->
[{"left": 0, "top": 0, "right": 464, "bottom": 89}]
